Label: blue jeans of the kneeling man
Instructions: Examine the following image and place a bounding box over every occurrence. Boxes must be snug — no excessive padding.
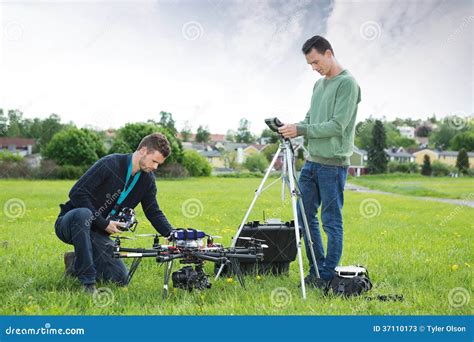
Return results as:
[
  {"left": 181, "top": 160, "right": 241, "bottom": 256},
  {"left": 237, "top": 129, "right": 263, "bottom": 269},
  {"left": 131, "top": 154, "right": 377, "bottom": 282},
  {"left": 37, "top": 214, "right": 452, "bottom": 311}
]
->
[{"left": 55, "top": 208, "right": 128, "bottom": 286}]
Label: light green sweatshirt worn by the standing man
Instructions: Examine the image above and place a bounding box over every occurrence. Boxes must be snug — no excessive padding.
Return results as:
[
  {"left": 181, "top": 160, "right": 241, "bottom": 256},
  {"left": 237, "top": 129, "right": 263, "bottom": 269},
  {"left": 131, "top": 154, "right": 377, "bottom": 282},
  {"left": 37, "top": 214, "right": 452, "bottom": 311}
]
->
[{"left": 296, "top": 70, "right": 360, "bottom": 166}]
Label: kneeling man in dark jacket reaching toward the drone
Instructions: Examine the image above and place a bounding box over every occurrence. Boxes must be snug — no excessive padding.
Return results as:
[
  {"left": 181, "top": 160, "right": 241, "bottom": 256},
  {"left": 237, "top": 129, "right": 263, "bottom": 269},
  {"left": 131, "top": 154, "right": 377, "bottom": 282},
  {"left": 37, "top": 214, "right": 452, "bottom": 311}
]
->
[{"left": 55, "top": 133, "right": 172, "bottom": 293}]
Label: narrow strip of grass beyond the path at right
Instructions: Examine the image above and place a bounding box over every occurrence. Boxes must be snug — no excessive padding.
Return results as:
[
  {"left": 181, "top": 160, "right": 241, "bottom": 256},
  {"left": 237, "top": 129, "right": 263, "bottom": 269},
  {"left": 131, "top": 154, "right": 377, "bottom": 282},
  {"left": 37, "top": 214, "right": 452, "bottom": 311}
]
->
[{"left": 348, "top": 174, "right": 474, "bottom": 201}]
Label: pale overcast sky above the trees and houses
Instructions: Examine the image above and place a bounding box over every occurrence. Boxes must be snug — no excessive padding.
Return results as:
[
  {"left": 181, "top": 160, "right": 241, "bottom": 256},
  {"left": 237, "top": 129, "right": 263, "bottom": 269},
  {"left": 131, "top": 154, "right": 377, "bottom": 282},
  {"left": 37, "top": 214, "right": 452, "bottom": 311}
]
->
[{"left": 0, "top": 0, "right": 474, "bottom": 133}]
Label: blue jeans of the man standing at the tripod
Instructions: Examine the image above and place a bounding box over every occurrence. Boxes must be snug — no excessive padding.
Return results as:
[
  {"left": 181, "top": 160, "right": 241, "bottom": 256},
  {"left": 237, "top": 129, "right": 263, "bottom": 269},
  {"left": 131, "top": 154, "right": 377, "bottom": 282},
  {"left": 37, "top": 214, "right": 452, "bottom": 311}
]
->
[{"left": 298, "top": 161, "right": 348, "bottom": 280}]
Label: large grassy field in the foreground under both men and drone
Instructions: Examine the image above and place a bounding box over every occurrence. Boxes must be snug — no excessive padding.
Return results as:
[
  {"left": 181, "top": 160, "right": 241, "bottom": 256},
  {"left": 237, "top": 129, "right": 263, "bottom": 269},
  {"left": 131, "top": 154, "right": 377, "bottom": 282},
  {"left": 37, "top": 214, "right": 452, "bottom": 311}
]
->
[{"left": 0, "top": 178, "right": 474, "bottom": 315}]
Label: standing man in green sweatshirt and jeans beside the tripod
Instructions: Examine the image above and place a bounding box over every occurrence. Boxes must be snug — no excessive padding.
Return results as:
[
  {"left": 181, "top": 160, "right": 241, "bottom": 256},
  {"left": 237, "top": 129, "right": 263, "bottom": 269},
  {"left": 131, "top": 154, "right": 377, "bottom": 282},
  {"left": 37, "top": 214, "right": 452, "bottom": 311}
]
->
[{"left": 279, "top": 36, "right": 361, "bottom": 288}]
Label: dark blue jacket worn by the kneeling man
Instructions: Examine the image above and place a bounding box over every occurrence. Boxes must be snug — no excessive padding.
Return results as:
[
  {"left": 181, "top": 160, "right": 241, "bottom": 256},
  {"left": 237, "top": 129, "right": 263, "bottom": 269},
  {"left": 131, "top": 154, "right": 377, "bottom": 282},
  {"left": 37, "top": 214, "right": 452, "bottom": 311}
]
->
[{"left": 59, "top": 154, "right": 173, "bottom": 236}]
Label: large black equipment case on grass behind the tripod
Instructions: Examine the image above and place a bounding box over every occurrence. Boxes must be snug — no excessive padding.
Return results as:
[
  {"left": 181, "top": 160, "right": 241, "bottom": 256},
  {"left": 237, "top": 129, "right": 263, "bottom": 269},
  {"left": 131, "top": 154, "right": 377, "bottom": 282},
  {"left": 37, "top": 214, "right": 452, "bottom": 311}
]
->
[{"left": 217, "top": 219, "right": 296, "bottom": 275}]
